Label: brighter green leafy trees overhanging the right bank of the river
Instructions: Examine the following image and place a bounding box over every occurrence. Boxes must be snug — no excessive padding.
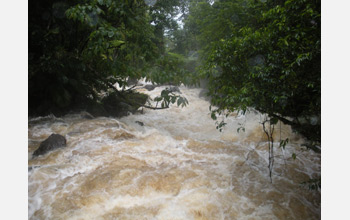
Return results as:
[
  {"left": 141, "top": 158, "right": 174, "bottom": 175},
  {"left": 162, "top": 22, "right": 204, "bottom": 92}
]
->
[{"left": 185, "top": 0, "right": 321, "bottom": 142}]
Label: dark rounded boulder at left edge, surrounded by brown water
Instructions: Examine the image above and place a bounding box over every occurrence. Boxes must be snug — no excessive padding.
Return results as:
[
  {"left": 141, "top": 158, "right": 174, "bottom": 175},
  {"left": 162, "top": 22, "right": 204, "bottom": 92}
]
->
[{"left": 33, "top": 134, "right": 67, "bottom": 157}]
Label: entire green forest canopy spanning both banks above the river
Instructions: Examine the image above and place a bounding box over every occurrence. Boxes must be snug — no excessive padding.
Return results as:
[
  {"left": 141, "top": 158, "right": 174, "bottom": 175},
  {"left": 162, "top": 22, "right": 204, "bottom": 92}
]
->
[{"left": 29, "top": 0, "right": 321, "bottom": 143}]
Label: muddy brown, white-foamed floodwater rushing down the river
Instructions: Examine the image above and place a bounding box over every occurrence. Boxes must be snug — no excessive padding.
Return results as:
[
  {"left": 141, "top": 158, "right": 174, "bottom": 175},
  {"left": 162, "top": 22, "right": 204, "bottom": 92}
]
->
[{"left": 28, "top": 86, "right": 321, "bottom": 220}]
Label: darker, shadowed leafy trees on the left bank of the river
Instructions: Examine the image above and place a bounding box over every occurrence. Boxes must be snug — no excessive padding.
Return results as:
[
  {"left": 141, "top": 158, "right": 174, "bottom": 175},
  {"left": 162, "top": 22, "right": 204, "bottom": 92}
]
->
[{"left": 29, "top": 0, "right": 190, "bottom": 114}]
